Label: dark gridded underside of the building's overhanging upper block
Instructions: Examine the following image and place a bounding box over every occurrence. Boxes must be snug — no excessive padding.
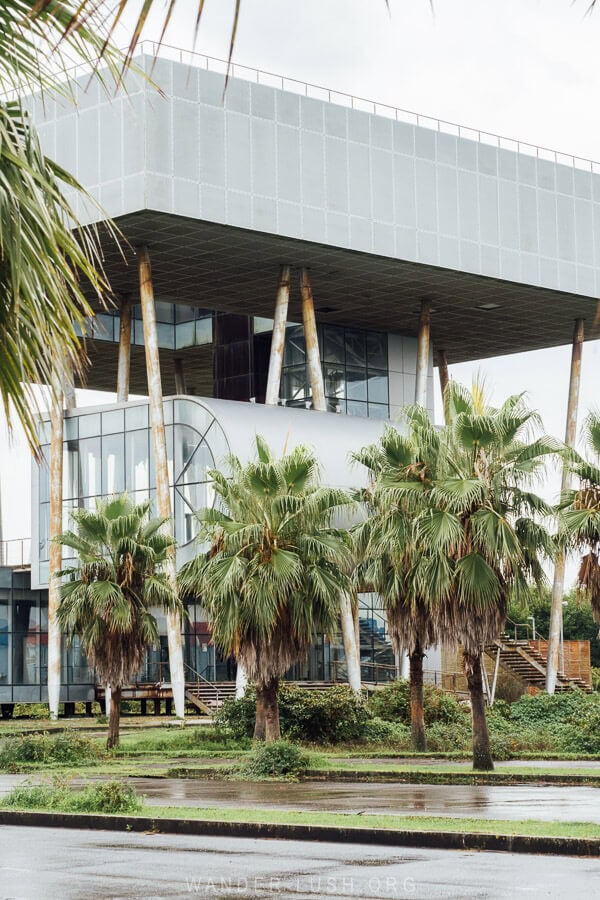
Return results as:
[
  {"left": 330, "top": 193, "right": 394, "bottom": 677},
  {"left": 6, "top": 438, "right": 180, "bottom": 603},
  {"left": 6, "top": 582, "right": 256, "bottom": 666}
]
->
[{"left": 84, "top": 210, "right": 600, "bottom": 370}]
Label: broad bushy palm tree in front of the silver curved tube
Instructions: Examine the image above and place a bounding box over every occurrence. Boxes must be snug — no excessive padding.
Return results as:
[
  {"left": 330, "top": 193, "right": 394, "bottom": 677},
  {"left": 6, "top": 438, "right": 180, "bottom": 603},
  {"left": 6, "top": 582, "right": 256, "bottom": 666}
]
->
[{"left": 180, "top": 437, "right": 351, "bottom": 741}]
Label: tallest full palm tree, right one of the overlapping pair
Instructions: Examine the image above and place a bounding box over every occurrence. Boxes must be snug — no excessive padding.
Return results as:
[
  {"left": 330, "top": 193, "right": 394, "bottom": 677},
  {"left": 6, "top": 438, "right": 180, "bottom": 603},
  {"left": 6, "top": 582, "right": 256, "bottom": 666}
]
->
[{"left": 426, "top": 382, "right": 561, "bottom": 770}]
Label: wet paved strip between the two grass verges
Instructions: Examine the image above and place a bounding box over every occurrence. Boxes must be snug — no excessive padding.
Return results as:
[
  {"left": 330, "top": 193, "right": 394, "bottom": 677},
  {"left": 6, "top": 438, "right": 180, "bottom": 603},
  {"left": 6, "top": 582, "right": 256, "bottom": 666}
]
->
[{"left": 0, "top": 775, "right": 600, "bottom": 824}]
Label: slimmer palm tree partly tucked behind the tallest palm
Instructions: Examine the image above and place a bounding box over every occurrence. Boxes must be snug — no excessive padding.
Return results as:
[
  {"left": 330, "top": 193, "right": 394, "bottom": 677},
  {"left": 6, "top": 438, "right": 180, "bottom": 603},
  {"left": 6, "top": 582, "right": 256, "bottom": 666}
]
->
[{"left": 353, "top": 405, "right": 442, "bottom": 752}]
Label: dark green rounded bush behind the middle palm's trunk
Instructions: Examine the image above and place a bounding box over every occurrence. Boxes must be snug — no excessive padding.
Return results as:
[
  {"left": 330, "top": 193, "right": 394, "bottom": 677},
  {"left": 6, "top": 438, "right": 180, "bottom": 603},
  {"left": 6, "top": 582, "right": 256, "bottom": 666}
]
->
[{"left": 216, "top": 684, "right": 369, "bottom": 744}]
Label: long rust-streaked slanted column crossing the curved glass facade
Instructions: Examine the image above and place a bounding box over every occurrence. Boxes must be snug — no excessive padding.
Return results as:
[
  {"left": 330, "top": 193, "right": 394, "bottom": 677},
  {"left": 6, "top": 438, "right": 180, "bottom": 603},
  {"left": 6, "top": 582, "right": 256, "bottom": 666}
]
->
[{"left": 138, "top": 247, "right": 185, "bottom": 719}]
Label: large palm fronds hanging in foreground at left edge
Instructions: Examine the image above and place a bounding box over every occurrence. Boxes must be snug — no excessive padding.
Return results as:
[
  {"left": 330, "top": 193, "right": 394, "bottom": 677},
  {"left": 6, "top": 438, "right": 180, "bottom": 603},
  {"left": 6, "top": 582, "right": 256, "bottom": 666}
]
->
[{"left": 0, "top": 0, "right": 119, "bottom": 447}]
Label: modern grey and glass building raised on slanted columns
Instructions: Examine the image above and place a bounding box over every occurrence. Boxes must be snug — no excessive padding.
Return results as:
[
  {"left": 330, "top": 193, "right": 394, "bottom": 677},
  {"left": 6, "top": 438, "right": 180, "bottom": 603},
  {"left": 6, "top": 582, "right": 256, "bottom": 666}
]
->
[{"left": 0, "top": 48, "right": 600, "bottom": 712}]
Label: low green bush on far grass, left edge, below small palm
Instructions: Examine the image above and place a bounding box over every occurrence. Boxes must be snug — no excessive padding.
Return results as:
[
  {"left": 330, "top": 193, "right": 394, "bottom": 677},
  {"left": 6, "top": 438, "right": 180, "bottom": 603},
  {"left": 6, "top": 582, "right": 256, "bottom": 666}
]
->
[{"left": 0, "top": 731, "right": 105, "bottom": 769}]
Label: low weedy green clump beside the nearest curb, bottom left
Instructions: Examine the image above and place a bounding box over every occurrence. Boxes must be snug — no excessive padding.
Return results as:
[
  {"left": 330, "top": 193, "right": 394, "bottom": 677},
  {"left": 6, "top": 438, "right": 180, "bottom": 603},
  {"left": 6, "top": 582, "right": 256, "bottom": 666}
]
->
[{"left": 1, "top": 779, "right": 142, "bottom": 814}]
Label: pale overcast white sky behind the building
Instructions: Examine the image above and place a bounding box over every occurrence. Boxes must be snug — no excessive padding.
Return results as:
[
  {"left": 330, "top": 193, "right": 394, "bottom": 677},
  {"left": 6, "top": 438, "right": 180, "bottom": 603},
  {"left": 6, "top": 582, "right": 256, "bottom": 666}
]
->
[{"left": 0, "top": 0, "right": 600, "bottom": 592}]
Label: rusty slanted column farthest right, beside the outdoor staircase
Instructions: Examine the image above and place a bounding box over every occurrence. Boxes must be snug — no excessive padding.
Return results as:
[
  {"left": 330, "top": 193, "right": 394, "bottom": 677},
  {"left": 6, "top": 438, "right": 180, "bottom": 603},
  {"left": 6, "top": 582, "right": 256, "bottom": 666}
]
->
[{"left": 546, "top": 319, "right": 584, "bottom": 694}]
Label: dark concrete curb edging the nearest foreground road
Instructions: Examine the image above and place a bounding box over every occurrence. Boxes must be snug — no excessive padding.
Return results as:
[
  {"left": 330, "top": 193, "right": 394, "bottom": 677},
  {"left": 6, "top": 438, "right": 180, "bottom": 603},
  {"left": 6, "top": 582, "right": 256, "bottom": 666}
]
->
[{"left": 0, "top": 810, "right": 600, "bottom": 857}]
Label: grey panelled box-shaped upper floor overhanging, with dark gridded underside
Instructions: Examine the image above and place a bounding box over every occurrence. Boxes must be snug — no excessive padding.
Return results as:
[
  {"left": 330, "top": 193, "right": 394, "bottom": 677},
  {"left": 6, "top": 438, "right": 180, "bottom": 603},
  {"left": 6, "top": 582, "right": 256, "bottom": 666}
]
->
[{"left": 27, "top": 44, "right": 600, "bottom": 362}]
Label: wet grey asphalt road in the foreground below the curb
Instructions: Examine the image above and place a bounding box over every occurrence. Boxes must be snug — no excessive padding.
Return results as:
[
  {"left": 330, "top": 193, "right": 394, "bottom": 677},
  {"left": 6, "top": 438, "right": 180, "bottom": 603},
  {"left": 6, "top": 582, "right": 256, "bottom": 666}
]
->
[{"left": 0, "top": 827, "right": 600, "bottom": 900}]
